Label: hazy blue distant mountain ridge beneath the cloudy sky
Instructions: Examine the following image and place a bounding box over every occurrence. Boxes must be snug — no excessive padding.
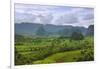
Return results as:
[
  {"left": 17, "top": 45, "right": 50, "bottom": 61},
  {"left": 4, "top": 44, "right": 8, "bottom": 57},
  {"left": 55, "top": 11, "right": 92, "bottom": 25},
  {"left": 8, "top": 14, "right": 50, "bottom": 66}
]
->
[{"left": 15, "top": 23, "right": 92, "bottom": 36}]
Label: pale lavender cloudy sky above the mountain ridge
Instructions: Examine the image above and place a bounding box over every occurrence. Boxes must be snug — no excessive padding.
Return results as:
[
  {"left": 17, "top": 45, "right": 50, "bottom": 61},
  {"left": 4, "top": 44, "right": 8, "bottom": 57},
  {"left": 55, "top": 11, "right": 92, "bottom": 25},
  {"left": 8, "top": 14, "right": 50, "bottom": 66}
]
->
[{"left": 14, "top": 3, "right": 94, "bottom": 27}]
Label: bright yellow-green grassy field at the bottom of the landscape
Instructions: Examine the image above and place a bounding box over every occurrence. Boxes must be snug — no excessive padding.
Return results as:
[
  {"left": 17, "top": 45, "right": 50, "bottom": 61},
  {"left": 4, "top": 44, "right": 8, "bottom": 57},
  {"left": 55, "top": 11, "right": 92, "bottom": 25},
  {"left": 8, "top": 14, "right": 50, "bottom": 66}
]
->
[{"left": 33, "top": 50, "right": 81, "bottom": 64}]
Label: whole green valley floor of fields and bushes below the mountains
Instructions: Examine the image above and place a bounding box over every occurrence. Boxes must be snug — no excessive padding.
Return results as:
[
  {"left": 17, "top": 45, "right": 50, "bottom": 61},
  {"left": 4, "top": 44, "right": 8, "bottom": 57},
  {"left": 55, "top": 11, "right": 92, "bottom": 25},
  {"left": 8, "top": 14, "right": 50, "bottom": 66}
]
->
[{"left": 15, "top": 35, "right": 94, "bottom": 65}]
